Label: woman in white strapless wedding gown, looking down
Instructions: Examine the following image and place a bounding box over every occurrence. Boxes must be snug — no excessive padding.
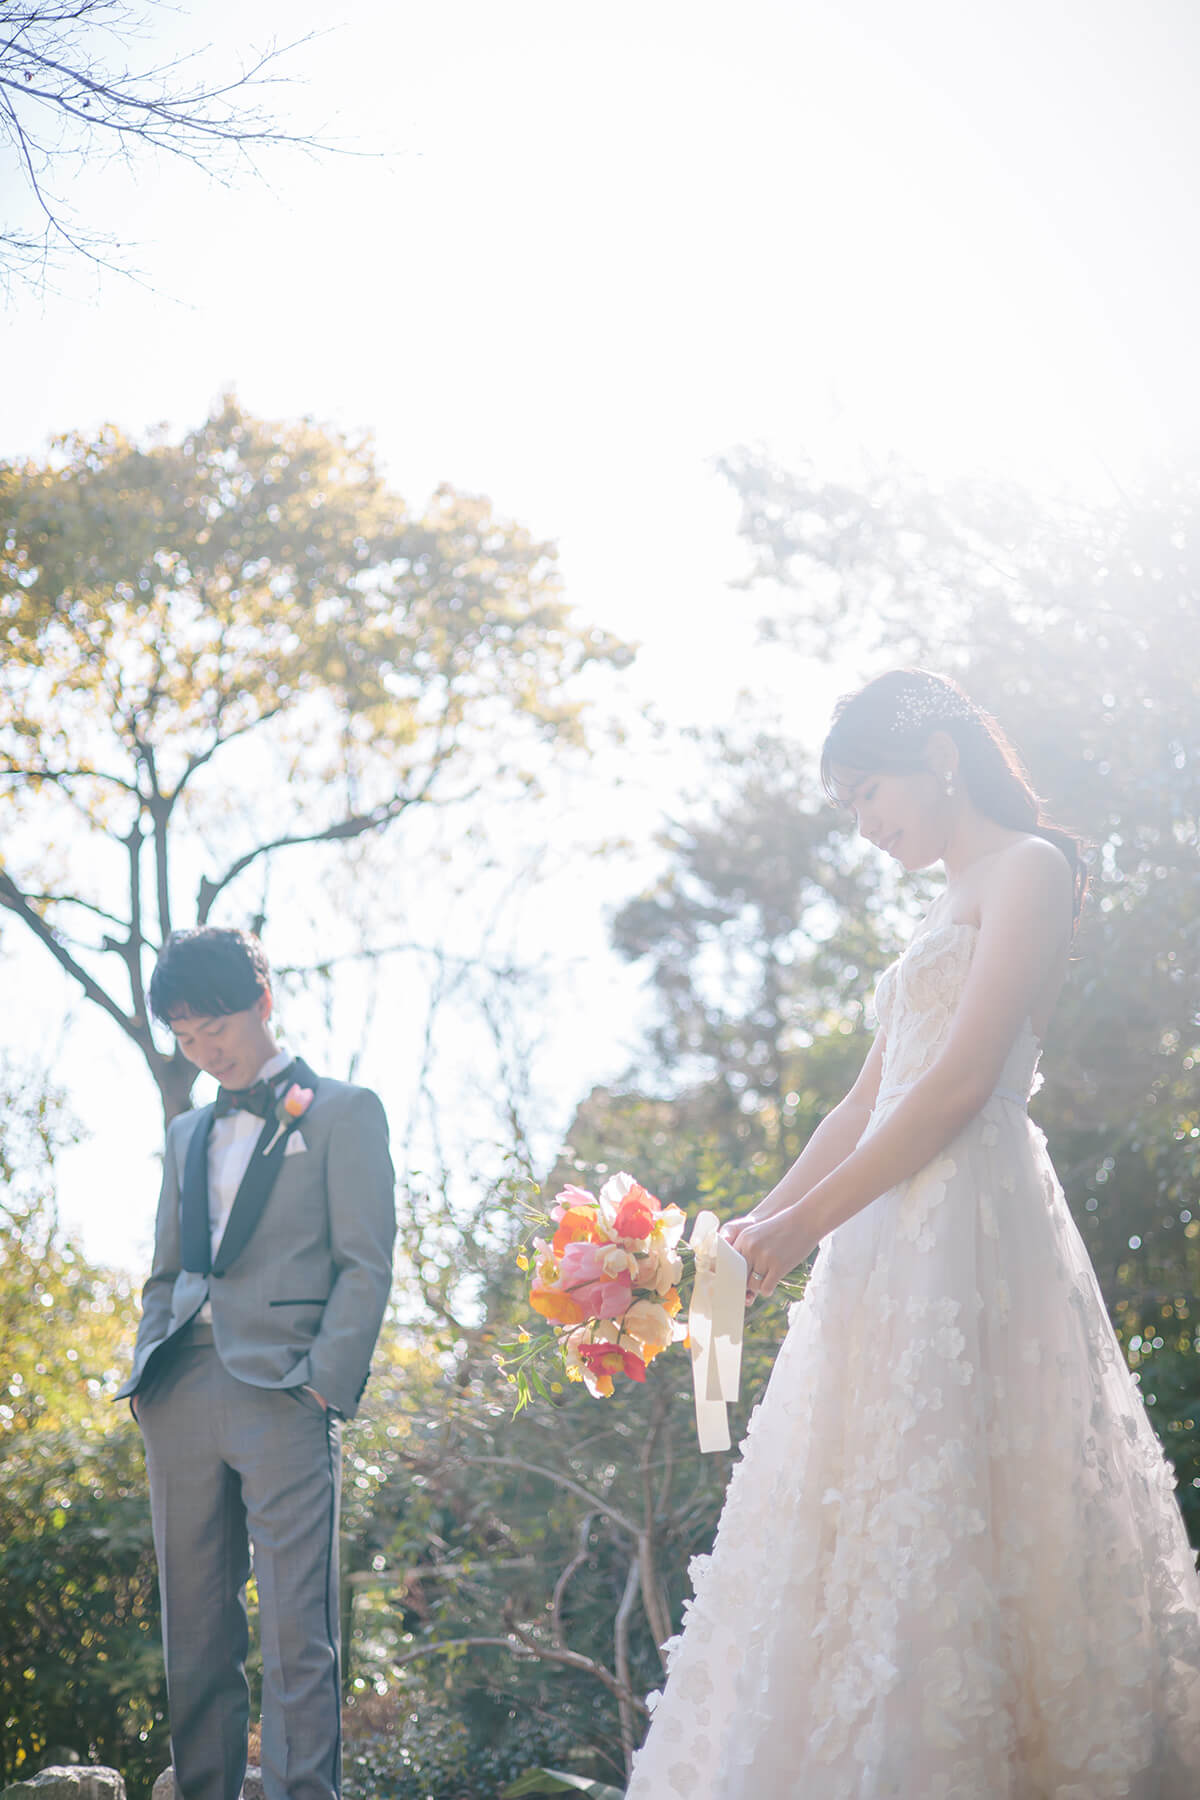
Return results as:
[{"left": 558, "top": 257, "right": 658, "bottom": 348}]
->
[{"left": 628, "top": 670, "right": 1200, "bottom": 1800}]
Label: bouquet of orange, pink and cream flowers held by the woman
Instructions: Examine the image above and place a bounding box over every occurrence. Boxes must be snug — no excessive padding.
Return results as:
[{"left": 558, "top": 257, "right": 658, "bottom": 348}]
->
[{"left": 498, "top": 1174, "right": 687, "bottom": 1413}]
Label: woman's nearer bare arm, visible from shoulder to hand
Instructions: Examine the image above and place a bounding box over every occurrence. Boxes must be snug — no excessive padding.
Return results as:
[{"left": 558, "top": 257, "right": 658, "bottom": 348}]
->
[{"left": 738, "top": 839, "right": 1072, "bottom": 1294}]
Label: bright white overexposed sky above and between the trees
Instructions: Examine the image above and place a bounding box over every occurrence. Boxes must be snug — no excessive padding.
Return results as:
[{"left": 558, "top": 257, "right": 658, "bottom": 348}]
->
[{"left": 0, "top": 0, "right": 1200, "bottom": 1267}]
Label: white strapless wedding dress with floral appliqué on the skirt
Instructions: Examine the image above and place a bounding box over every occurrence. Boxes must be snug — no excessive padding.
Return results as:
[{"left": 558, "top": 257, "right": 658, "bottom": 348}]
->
[{"left": 628, "top": 920, "right": 1200, "bottom": 1800}]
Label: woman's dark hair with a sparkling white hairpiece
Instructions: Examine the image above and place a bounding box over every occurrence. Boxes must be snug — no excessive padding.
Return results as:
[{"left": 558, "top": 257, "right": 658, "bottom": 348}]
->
[{"left": 820, "top": 668, "right": 1088, "bottom": 922}]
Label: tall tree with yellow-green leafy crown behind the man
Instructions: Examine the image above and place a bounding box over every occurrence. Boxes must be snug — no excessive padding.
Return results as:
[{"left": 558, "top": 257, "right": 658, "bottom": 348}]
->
[{"left": 0, "top": 398, "right": 630, "bottom": 1116}]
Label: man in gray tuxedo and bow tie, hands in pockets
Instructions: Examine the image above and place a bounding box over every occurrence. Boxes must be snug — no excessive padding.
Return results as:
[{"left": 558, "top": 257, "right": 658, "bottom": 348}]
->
[{"left": 121, "top": 929, "right": 396, "bottom": 1800}]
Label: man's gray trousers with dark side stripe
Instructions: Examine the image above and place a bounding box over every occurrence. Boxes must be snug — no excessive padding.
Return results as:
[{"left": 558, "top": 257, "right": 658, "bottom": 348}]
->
[{"left": 137, "top": 1327, "right": 342, "bottom": 1800}]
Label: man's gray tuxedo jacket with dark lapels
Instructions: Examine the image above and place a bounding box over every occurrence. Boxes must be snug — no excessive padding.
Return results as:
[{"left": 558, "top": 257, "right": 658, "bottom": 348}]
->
[{"left": 117, "top": 1076, "right": 396, "bottom": 1418}]
